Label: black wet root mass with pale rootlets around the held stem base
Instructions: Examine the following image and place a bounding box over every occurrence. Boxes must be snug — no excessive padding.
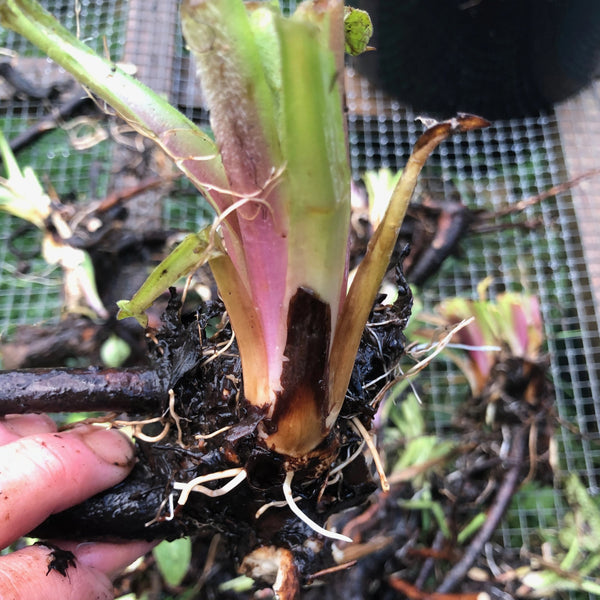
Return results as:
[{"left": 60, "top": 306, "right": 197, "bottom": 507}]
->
[{"left": 34, "top": 267, "right": 412, "bottom": 574}]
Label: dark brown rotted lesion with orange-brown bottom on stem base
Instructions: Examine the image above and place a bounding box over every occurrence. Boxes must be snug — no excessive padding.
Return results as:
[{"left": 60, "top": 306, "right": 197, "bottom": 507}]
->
[{"left": 265, "top": 287, "right": 331, "bottom": 456}]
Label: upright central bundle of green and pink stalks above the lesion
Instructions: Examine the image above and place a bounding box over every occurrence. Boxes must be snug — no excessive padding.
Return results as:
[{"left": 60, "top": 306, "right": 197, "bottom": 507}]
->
[{"left": 181, "top": 0, "right": 350, "bottom": 424}]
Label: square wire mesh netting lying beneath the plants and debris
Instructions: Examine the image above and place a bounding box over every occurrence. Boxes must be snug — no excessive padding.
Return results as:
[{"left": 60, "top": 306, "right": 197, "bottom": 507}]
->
[{"left": 0, "top": 0, "right": 600, "bottom": 597}]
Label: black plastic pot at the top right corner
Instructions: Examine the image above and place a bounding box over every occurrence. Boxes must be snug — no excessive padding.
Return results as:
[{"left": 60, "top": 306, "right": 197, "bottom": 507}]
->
[{"left": 356, "top": 0, "right": 600, "bottom": 119}]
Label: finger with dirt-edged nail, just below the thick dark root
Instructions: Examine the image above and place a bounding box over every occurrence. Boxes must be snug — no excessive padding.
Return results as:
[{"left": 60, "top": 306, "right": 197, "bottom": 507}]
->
[{"left": 0, "top": 426, "right": 134, "bottom": 547}]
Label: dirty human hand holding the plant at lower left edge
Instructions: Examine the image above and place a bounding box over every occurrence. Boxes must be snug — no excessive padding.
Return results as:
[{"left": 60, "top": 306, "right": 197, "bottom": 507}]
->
[{"left": 0, "top": 415, "right": 152, "bottom": 600}]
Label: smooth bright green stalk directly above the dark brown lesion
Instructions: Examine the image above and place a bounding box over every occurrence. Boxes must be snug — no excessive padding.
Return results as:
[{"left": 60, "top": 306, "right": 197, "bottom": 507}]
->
[{"left": 279, "top": 7, "right": 350, "bottom": 324}]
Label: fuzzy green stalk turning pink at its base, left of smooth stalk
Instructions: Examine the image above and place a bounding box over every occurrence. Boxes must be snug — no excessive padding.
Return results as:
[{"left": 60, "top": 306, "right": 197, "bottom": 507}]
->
[{"left": 181, "top": 0, "right": 289, "bottom": 390}]
